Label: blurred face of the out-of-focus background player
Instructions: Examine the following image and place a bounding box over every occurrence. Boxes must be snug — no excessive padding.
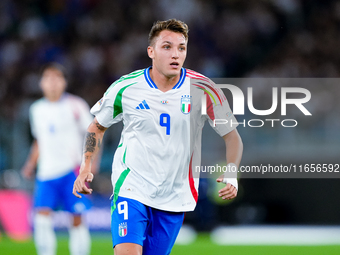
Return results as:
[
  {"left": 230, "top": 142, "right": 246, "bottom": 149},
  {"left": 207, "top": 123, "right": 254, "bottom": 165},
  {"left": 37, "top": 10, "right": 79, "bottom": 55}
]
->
[{"left": 40, "top": 69, "right": 66, "bottom": 101}]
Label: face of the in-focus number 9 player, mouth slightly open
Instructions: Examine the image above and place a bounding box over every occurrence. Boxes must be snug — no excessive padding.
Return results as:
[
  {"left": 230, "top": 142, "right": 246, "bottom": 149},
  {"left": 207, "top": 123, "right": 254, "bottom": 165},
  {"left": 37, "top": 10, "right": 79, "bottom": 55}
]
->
[{"left": 148, "top": 30, "right": 187, "bottom": 78}]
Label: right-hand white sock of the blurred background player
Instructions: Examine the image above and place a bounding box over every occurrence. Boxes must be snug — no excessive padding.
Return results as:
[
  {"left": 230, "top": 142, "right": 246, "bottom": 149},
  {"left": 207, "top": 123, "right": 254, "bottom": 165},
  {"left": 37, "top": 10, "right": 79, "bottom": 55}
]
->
[{"left": 69, "top": 224, "right": 91, "bottom": 255}]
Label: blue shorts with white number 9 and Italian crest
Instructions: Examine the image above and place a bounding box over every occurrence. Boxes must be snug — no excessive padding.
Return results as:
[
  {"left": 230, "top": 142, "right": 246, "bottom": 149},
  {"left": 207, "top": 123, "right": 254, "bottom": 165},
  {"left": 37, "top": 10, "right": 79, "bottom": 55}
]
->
[{"left": 111, "top": 197, "right": 184, "bottom": 255}]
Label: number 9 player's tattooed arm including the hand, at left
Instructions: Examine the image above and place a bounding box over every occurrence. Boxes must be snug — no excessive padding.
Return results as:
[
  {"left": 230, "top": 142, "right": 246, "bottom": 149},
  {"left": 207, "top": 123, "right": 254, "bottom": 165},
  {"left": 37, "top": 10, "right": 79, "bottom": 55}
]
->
[{"left": 73, "top": 118, "right": 107, "bottom": 198}]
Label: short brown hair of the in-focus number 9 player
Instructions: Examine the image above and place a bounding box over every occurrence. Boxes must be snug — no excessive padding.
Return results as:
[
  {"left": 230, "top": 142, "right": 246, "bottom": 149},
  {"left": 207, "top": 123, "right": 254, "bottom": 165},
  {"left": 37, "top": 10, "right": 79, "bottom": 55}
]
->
[{"left": 149, "top": 19, "right": 189, "bottom": 46}]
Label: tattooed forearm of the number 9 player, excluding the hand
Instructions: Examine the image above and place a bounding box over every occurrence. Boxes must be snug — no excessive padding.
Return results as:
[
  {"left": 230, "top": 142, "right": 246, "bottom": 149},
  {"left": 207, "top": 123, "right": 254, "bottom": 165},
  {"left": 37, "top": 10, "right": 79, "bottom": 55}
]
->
[{"left": 80, "top": 118, "right": 106, "bottom": 172}]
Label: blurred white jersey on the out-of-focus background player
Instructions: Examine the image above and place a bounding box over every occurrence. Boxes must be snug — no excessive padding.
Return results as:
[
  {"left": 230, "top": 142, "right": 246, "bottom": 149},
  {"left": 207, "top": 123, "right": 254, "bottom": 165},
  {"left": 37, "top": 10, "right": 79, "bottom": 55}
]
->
[{"left": 30, "top": 93, "right": 93, "bottom": 181}]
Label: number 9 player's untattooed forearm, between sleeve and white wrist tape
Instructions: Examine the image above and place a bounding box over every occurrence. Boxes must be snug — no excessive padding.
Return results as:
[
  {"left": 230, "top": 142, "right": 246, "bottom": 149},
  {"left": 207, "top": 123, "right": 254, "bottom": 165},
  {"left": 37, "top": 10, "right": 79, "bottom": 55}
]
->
[{"left": 223, "top": 130, "right": 243, "bottom": 167}]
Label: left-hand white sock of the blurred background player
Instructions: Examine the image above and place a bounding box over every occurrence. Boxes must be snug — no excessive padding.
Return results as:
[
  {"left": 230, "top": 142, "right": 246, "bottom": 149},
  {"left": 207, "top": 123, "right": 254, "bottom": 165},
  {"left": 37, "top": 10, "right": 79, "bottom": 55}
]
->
[{"left": 34, "top": 214, "right": 57, "bottom": 255}]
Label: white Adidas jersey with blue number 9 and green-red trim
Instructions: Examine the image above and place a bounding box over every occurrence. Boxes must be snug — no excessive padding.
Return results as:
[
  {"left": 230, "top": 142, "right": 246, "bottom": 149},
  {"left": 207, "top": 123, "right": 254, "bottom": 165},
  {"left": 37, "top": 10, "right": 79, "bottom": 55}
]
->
[{"left": 91, "top": 67, "right": 236, "bottom": 212}]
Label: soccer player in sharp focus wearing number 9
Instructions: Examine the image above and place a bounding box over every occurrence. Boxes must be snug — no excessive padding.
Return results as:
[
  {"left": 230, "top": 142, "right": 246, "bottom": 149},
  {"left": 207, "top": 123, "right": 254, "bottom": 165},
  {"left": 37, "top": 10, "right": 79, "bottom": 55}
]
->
[{"left": 73, "top": 19, "right": 243, "bottom": 255}]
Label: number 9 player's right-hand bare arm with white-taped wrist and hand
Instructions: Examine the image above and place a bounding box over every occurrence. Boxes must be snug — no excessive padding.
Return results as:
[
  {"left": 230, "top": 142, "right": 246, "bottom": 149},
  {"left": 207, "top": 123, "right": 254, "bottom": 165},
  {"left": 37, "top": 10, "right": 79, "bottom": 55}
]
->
[{"left": 217, "top": 129, "right": 243, "bottom": 199}]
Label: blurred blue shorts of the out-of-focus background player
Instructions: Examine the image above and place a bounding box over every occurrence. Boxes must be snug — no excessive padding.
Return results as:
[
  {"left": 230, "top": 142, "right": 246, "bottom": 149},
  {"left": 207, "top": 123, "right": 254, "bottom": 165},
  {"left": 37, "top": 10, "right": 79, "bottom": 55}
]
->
[{"left": 34, "top": 172, "right": 91, "bottom": 214}]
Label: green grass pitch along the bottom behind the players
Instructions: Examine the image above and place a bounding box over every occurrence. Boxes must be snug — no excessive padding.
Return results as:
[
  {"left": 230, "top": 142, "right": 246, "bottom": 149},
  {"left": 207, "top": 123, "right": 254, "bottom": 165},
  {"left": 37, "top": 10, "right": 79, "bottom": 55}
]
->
[{"left": 0, "top": 234, "right": 340, "bottom": 255}]
